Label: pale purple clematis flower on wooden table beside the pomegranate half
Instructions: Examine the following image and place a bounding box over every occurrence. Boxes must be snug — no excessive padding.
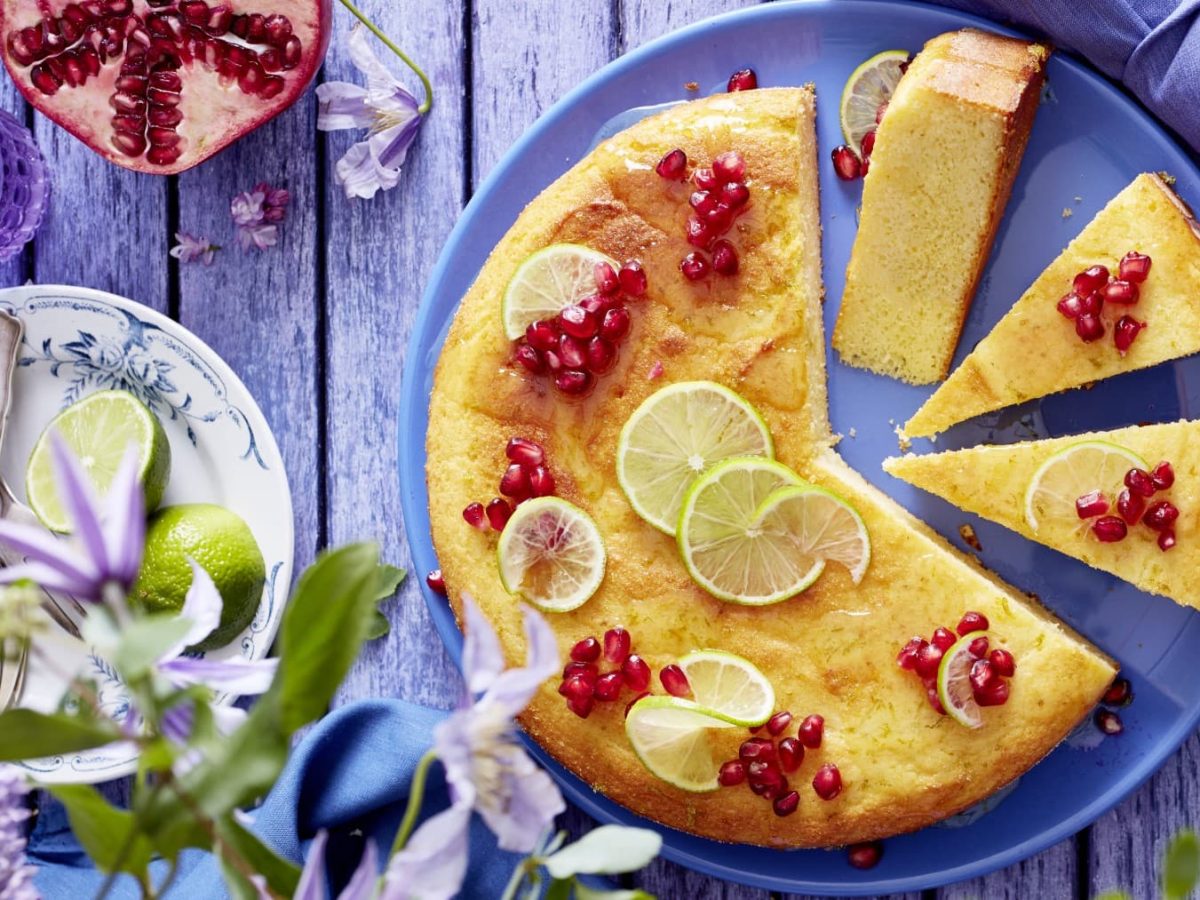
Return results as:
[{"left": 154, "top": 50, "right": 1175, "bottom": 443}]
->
[{"left": 317, "top": 26, "right": 425, "bottom": 198}]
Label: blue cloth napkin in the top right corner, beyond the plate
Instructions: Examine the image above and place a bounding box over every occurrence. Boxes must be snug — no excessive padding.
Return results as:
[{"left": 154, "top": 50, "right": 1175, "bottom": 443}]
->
[{"left": 934, "top": 0, "right": 1200, "bottom": 152}]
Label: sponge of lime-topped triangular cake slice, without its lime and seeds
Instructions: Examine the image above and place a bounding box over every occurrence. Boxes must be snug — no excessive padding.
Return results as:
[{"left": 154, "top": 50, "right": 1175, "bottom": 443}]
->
[{"left": 883, "top": 421, "right": 1200, "bottom": 607}]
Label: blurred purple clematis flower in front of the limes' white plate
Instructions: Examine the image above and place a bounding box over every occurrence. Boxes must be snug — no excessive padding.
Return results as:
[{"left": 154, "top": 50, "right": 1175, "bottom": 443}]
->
[{"left": 0, "top": 432, "right": 145, "bottom": 602}]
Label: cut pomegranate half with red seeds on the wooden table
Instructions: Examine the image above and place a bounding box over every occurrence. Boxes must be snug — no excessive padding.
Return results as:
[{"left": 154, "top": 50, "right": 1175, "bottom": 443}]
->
[{"left": 0, "top": 0, "right": 331, "bottom": 175}]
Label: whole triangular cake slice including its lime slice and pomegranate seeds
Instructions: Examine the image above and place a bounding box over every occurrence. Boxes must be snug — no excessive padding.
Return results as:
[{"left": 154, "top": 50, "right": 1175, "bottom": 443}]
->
[{"left": 883, "top": 421, "right": 1200, "bottom": 607}]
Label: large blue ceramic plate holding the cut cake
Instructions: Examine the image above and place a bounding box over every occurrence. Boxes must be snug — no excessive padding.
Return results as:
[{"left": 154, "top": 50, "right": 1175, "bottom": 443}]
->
[{"left": 400, "top": 0, "right": 1200, "bottom": 895}]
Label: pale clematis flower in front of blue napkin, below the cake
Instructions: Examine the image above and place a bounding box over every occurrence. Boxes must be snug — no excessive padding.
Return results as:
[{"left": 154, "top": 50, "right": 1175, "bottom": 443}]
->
[{"left": 384, "top": 594, "right": 566, "bottom": 900}]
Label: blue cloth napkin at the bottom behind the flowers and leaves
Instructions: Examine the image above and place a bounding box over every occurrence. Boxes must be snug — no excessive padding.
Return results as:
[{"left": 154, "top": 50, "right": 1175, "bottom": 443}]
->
[{"left": 28, "top": 700, "right": 520, "bottom": 900}]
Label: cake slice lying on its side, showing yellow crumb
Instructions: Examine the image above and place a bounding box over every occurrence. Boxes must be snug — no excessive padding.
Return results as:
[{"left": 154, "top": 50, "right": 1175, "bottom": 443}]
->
[{"left": 833, "top": 29, "right": 1050, "bottom": 384}]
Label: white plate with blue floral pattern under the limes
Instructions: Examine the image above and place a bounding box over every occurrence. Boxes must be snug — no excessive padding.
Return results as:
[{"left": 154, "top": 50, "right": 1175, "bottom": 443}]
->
[{"left": 0, "top": 286, "right": 293, "bottom": 784}]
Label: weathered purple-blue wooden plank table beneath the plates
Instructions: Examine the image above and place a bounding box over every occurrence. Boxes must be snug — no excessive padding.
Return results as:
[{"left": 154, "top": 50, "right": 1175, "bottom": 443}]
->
[{"left": 0, "top": 0, "right": 1200, "bottom": 900}]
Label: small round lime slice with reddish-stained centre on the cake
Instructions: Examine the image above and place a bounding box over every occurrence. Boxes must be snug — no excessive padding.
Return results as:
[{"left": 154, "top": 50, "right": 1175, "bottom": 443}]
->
[{"left": 496, "top": 497, "right": 605, "bottom": 612}]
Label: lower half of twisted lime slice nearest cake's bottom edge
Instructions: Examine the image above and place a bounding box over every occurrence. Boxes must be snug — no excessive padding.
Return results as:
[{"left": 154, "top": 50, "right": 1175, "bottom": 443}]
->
[{"left": 625, "top": 696, "right": 736, "bottom": 793}]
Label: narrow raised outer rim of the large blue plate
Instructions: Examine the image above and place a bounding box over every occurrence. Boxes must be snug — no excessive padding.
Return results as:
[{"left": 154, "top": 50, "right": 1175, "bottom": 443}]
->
[{"left": 397, "top": 0, "right": 1200, "bottom": 896}]
